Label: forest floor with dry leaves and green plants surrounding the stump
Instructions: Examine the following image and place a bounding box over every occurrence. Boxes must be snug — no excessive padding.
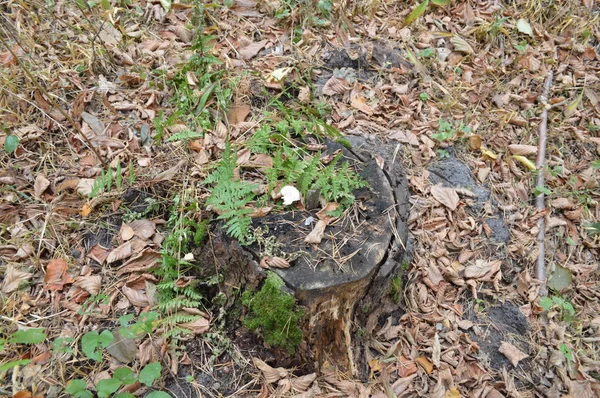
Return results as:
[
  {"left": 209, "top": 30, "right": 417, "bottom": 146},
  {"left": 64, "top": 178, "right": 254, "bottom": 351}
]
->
[{"left": 0, "top": 0, "right": 600, "bottom": 398}]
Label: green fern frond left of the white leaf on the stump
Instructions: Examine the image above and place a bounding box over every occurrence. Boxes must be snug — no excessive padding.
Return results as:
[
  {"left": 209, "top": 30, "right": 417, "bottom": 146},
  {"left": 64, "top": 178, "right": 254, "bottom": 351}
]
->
[{"left": 204, "top": 145, "right": 258, "bottom": 243}]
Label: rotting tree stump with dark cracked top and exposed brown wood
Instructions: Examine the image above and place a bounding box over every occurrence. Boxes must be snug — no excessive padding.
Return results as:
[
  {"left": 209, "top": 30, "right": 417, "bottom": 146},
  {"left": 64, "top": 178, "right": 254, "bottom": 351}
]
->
[{"left": 196, "top": 136, "right": 408, "bottom": 377}]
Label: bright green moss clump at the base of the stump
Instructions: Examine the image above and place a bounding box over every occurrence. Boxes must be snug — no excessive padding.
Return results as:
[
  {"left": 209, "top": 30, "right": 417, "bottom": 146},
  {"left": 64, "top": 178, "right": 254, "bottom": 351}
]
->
[{"left": 242, "top": 272, "right": 304, "bottom": 354}]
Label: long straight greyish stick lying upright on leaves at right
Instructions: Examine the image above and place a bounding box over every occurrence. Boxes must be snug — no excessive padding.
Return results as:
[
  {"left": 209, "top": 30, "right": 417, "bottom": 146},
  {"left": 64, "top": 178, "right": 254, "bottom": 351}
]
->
[{"left": 535, "top": 71, "right": 554, "bottom": 296}]
